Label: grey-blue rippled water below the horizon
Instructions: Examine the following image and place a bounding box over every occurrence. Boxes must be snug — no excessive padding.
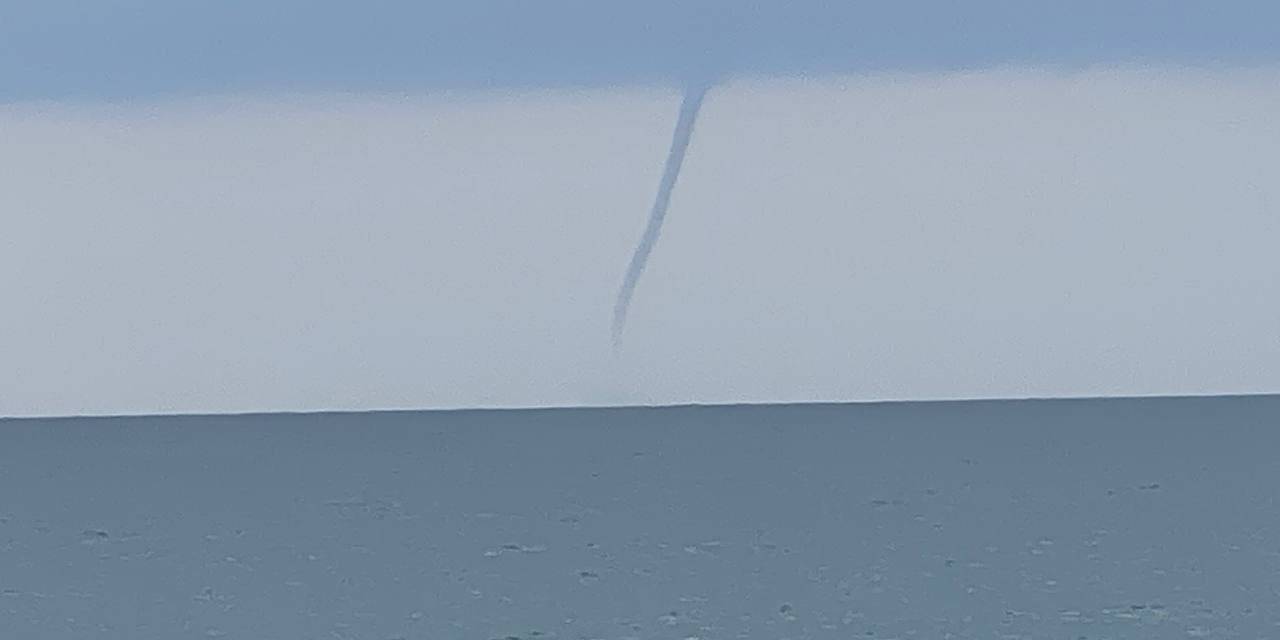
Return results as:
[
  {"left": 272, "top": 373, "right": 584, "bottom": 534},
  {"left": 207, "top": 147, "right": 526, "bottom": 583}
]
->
[{"left": 0, "top": 397, "right": 1280, "bottom": 640}]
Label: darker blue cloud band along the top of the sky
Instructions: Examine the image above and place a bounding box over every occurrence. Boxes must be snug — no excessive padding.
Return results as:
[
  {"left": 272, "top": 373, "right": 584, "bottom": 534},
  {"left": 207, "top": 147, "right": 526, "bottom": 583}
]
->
[{"left": 0, "top": 0, "right": 1280, "bottom": 101}]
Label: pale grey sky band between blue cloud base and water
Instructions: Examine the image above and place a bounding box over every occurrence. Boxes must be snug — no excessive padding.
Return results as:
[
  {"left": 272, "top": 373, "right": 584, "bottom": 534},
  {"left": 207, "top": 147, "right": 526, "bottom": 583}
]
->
[{"left": 0, "top": 69, "right": 1280, "bottom": 415}]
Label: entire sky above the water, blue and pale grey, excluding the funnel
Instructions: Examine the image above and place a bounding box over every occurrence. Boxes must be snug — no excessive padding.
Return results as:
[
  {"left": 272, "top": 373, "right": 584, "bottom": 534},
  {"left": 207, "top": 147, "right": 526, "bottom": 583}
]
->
[{"left": 0, "top": 1, "right": 1280, "bottom": 415}]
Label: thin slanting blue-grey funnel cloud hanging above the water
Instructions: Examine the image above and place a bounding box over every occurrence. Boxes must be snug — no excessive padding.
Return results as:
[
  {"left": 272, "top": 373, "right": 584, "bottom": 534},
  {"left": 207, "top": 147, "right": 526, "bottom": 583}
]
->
[{"left": 613, "top": 83, "right": 710, "bottom": 351}]
